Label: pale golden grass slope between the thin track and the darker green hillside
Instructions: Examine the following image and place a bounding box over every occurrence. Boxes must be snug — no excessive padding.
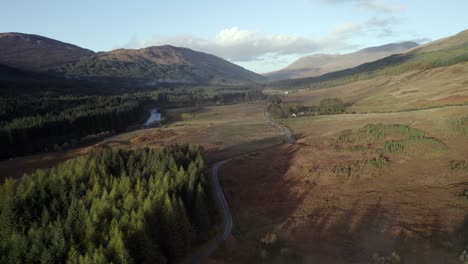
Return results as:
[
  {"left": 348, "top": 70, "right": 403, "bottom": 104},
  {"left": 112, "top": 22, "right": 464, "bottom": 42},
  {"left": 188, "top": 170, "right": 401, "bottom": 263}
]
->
[{"left": 285, "top": 63, "right": 468, "bottom": 112}]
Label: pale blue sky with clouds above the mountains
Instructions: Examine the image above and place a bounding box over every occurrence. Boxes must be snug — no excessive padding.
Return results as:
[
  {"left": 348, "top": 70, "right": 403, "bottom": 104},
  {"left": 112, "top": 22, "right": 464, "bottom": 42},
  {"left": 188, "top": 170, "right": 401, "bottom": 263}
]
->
[{"left": 0, "top": 0, "right": 468, "bottom": 73}]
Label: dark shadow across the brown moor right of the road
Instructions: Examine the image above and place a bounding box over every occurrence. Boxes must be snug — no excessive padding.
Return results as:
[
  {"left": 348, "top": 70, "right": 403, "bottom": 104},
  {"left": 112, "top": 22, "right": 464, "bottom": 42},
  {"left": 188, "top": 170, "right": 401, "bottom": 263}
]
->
[{"left": 207, "top": 131, "right": 468, "bottom": 264}]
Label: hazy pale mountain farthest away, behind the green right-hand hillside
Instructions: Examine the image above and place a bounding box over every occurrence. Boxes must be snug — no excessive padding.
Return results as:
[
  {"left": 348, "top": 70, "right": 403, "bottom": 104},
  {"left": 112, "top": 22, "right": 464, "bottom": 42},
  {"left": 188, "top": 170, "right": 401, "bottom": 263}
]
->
[{"left": 264, "top": 42, "right": 418, "bottom": 80}]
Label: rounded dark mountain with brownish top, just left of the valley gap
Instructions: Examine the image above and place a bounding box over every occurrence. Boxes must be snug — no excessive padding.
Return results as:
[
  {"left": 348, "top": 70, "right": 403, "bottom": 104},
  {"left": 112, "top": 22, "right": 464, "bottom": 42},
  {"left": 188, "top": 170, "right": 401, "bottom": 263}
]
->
[{"left": 57, "top": 46, "right": 265, "bottom": 85}]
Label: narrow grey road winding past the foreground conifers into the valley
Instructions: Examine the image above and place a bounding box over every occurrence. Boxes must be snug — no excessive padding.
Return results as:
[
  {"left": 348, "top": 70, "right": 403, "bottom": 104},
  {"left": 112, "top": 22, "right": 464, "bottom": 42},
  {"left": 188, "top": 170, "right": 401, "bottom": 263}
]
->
[{"left": 189, "top": 106, "right": 296, "bottom": 264}]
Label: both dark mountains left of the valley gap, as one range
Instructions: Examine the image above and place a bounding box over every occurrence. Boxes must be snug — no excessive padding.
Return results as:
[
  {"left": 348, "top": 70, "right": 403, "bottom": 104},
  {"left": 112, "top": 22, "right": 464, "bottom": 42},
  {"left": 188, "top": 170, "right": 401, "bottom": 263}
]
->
[{"left": 0, "top": 33, "right": 266, "bottom": 86}]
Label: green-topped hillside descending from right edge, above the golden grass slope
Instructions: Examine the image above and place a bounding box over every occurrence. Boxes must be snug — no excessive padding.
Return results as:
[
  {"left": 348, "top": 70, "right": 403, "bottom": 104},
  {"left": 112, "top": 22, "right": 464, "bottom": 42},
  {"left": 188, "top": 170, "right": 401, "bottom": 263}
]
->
[{"left": 269, "top": 30, "right": 468, "bottom": 89}]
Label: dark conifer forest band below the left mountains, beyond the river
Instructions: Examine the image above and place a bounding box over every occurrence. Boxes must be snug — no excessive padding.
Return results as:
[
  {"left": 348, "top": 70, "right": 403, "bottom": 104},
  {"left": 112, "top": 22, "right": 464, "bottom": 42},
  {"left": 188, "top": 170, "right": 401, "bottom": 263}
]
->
[{"left": 0, "top": 89, "right": 264, "bottom": 158}]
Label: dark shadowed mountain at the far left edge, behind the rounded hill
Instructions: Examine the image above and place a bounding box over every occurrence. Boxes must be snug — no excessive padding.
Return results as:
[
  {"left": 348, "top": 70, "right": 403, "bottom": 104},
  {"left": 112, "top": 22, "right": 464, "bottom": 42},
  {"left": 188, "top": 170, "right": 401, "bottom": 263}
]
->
[{"left": 0, "top": 33, "right": 94, "bottom": 72}]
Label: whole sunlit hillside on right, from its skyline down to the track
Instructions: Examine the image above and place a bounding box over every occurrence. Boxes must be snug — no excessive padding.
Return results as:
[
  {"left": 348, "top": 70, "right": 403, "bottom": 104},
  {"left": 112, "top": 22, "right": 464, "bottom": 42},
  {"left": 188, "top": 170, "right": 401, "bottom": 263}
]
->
[{"left": 284, "top": 31, "right": 468, "bottom": 112}]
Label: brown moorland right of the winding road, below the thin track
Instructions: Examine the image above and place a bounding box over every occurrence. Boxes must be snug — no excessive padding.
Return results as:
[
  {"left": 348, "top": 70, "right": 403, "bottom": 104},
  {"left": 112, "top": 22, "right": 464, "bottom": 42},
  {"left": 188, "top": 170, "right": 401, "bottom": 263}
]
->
[{"left": 207, "top": 106, "right": 468, "bottom": 264}]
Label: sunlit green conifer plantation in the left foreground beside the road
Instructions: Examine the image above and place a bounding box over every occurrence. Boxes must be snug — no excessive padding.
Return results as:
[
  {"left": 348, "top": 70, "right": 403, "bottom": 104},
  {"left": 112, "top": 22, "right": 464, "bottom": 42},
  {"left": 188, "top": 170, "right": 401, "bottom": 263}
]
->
[{"left": 0, "top": 145, "right": 218, "bottom": 263}]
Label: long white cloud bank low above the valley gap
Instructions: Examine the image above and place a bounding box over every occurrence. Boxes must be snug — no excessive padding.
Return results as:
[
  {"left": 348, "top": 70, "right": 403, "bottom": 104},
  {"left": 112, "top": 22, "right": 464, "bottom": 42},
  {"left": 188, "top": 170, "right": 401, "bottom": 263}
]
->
[{"left": 123, "top": 23, "right": 361, "bottom": 62}]
